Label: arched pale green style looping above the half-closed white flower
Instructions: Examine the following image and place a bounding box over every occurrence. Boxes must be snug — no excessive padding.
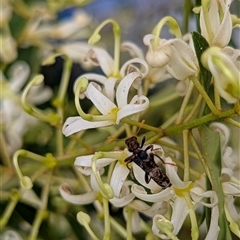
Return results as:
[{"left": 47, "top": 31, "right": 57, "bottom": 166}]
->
[{"left": 153, "top": 16, "right": 182, "bottom": 49}]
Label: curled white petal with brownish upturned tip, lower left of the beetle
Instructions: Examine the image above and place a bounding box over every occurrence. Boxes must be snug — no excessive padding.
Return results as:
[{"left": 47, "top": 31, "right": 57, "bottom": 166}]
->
[{"left": 59, "top": 184, "right": 97, "bottom": 205}]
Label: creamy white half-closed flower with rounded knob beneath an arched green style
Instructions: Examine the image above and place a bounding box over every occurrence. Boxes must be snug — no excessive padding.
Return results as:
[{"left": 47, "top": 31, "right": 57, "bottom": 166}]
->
[{"left": 143, "top": 34, "right": 199, "bottom": 80}]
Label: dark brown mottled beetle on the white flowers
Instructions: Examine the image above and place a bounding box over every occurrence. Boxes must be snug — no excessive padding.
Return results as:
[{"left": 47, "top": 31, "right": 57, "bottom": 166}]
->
[{"left": 124, "top": 136, "right": 172, "bottom": 188}]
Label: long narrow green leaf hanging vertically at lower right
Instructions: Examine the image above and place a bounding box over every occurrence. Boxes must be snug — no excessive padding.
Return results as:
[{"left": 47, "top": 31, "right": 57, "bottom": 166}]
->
[{"left": 199, "top": 125, "right": 232, "bottom": 240}]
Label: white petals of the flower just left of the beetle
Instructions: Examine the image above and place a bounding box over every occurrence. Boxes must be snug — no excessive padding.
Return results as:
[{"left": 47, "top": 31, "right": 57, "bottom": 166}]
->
[{"left": 60, "top": 151, "right": 135, "bottom": 207}]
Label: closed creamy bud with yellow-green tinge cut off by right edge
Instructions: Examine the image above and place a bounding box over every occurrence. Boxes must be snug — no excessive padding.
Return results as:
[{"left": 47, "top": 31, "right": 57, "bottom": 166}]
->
[{"left": 201, "top": 47, "right": 240, "bottom": 103}]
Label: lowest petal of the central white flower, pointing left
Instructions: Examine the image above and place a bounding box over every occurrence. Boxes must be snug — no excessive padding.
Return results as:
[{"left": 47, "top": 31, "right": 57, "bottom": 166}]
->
[{"left": 62, "top": 117, "right": 113, "bottom": 137}]
